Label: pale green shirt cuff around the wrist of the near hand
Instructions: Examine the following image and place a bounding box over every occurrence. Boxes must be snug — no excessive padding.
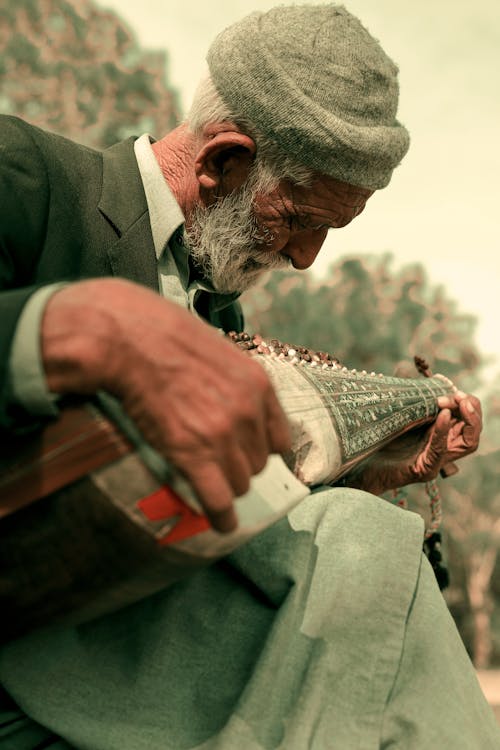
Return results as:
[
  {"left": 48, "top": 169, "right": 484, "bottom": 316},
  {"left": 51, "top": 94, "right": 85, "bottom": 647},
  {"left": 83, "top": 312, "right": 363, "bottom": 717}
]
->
[{"left": 8, "top": 283, "right": 67, "bottom": 417}]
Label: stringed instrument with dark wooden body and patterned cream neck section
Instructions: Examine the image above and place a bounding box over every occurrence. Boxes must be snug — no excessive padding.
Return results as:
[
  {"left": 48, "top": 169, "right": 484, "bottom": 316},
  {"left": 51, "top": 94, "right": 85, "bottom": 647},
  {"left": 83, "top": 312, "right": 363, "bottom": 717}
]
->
[{"left": 0, "top": 352, "right": 453, "bottom": 640}]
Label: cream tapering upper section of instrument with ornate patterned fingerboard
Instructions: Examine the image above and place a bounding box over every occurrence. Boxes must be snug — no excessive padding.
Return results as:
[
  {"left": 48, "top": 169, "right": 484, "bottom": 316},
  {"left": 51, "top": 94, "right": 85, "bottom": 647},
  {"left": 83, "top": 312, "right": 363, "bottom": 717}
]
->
[{"left": 256, "top": 354, "right": 455, "bottom": 485}]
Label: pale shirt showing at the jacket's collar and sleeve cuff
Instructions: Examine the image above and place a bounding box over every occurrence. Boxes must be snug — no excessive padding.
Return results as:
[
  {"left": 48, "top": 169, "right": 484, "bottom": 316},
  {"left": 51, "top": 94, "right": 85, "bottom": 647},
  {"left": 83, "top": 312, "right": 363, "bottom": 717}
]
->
[{"left": 9, "top": 133, "right": 238, "bottom": 416}]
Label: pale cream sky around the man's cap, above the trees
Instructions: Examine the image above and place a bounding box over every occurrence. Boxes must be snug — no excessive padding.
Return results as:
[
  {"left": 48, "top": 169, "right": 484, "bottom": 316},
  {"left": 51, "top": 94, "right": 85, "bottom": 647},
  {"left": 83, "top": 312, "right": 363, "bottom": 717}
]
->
[{"left": 100, "top": 0, "right": 500, "bottom": 382}]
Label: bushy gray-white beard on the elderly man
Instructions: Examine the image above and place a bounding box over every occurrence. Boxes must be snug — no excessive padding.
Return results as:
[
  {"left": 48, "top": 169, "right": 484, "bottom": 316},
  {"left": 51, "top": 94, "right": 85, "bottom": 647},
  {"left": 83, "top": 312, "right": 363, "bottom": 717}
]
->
[{"left": 184, "top": 187, "right": 290, "bottom": 294}]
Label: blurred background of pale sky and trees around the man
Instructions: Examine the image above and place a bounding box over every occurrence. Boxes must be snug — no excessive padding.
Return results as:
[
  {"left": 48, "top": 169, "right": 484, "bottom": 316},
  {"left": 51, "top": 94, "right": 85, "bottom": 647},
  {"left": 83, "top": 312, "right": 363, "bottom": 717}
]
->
[{"left": 0, "top": 0, "right": 500, "bottom": 692}]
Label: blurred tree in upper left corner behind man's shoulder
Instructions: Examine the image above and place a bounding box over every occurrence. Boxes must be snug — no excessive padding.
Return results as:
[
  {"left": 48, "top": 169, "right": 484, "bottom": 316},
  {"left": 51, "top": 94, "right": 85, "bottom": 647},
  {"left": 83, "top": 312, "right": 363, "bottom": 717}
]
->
[{"left": 0, "top": 0, "right": 179, "bottom": 147}]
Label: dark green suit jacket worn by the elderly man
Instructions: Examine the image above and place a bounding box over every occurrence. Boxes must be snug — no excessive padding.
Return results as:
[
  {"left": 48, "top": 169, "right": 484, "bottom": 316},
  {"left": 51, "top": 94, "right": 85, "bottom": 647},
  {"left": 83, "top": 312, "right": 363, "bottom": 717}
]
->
[{"left": 0, "top": 116, "right": 242, "bottom": 430}]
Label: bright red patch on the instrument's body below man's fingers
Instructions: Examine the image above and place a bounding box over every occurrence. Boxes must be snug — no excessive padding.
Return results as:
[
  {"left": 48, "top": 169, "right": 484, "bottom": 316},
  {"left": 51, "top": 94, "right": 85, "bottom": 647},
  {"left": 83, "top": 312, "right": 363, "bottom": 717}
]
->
[{"left": 137, "top": 485, "right": 210, "bottom": 545}]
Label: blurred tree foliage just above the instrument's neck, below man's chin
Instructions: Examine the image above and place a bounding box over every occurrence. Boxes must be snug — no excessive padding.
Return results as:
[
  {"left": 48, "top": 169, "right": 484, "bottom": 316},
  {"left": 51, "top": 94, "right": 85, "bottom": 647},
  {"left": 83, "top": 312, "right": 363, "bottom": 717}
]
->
[{"left": 242, "top": 254, "right": 481, "bottom": 389}]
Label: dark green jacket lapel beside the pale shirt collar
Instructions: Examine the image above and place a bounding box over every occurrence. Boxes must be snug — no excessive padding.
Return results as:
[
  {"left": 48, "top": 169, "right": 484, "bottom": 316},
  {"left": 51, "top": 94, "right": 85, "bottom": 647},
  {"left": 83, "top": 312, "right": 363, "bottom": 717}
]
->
[{"left": 98, "top": 138, "right": 159, "bottom": 291}]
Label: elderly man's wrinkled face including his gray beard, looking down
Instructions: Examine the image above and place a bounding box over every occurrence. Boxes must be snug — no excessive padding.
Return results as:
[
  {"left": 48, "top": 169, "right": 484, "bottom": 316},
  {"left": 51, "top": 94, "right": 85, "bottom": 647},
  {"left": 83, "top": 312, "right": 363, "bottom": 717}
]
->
[{"left": 186, "top": 175, "right": 373, "bottom": 293}]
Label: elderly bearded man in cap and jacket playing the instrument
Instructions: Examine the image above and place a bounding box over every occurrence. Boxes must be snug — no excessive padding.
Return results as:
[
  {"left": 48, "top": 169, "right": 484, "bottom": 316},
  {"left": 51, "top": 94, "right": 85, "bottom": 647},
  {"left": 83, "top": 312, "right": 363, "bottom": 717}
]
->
[{"left": 0, "top": 5, "right": 499, "bottom": 750}]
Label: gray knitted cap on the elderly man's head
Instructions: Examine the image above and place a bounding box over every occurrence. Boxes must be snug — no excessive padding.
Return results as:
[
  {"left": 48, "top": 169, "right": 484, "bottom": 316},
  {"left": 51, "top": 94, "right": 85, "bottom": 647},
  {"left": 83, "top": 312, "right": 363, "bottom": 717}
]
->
[{"left": 207, "top": 5, "right": 409, "bottom": 189}]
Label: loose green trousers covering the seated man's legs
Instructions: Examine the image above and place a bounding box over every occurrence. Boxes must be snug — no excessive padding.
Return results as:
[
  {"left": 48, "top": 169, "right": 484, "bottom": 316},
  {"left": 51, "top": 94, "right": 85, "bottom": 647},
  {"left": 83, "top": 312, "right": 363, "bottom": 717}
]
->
[{"left": 0, "top": 489, "right": 500, "bottom": 750}]
